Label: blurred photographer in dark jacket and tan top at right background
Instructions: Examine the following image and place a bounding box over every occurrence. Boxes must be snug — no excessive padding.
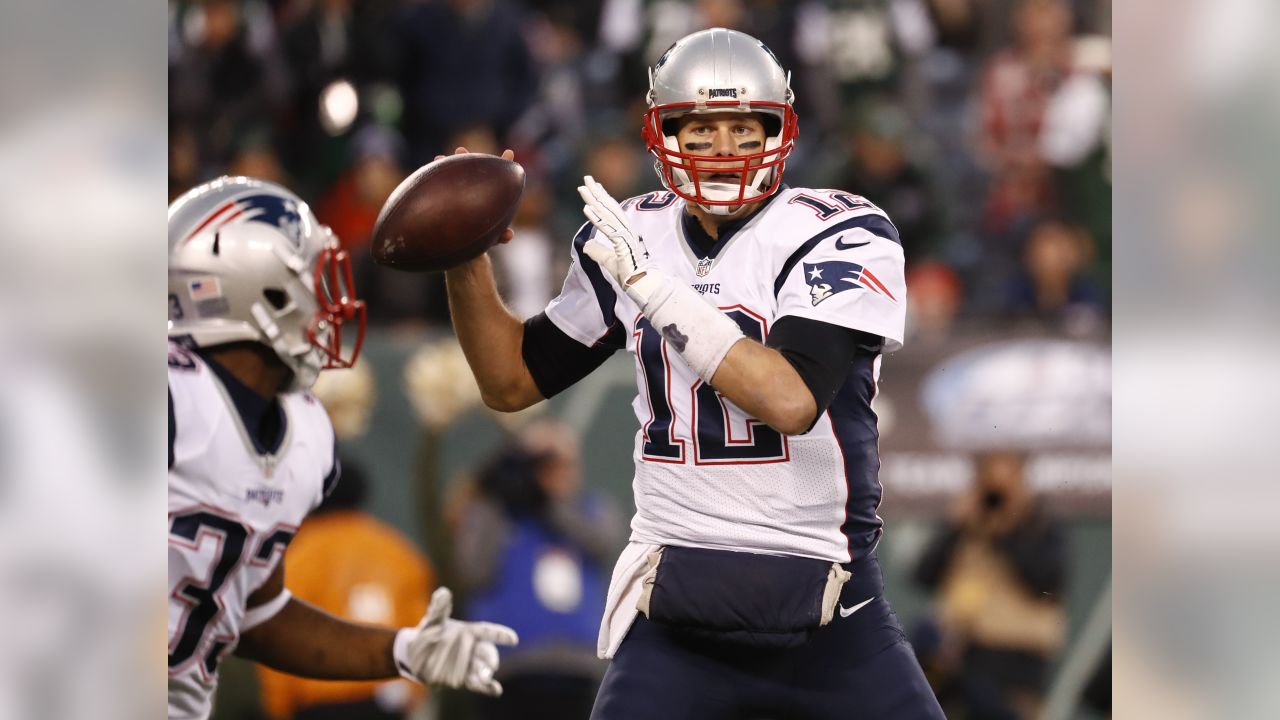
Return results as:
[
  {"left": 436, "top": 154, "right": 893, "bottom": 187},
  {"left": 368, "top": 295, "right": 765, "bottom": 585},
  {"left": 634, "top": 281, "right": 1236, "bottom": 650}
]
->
[{"left": 913, "top": 452, "right": 1068, "bottom": 720}]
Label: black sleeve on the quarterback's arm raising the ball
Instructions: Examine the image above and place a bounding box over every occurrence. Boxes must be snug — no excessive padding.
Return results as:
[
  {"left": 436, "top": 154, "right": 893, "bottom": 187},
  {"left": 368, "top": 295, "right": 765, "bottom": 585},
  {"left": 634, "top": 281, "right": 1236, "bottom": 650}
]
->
[{"left": 520, "top": 313, "right": 625, "bottom": 397}]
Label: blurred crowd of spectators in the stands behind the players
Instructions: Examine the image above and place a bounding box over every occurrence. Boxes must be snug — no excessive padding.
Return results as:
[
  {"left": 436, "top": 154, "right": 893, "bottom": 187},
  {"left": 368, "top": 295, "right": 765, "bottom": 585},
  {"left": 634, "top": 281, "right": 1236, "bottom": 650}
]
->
[{"left": 169, "top": 0, "right": 1111, "bottom": 342}]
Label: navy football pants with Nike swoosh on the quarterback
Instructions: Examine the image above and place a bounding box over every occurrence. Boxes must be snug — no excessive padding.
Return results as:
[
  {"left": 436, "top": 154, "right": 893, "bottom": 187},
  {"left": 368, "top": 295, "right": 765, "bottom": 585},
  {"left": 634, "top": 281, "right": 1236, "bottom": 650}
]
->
[{"left": 591, "top": 559, "right": 945, "bottom": 720}]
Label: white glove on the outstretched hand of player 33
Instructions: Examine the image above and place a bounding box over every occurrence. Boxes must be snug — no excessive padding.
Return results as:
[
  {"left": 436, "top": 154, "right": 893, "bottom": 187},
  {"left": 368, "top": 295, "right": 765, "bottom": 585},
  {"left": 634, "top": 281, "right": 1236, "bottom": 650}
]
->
[{"left": 392, "top": 588, "right": 520, "bottom": 697}]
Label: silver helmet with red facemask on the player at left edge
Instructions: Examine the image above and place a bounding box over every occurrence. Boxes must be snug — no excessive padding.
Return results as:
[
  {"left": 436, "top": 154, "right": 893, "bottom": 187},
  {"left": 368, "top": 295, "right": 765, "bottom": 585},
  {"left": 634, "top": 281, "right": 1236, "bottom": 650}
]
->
[{"left": 169, "top": 177, "right": 365, "bottom": 389}]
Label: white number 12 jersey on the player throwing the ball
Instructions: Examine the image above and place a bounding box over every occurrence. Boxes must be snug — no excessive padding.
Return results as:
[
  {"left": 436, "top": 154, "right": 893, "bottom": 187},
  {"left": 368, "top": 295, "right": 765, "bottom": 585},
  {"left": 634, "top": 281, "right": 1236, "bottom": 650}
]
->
[{"left": 547, "top": 187, "right": 906, "bottom": 562}]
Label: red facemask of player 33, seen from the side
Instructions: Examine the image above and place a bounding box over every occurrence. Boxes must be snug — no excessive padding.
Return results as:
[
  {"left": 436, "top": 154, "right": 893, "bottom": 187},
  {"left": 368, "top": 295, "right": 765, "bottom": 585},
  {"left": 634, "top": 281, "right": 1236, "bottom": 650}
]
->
[{"left": 307, "top": 247, "right": 366, "bottom": 370}]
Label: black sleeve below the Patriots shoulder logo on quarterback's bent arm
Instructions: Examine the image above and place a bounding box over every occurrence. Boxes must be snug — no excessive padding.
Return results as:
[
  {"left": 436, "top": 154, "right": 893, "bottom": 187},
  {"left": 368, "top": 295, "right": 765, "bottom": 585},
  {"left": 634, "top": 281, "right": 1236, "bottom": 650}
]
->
[{"left": 765, "top": 315, "right": 884, "bottom": 432}]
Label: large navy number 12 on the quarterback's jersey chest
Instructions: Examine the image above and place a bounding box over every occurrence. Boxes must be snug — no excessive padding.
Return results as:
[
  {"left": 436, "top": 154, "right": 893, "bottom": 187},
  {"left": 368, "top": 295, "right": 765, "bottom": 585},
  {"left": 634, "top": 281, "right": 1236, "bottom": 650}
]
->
[{"left": 634, "top": 307, "right": 790, "bottom": 465}]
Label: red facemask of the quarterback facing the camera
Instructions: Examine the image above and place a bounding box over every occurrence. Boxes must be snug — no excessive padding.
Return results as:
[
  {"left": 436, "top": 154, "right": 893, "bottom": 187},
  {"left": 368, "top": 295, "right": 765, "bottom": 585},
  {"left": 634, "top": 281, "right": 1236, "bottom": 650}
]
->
[{"left": 641, "top": 100, "right": 800, "bottom": 206}]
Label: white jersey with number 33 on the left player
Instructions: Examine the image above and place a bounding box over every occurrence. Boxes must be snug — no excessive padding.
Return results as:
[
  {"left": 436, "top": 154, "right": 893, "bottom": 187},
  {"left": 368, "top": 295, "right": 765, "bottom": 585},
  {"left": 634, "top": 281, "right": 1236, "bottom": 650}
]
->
[{"left": 169, "top": 343, "right": 339, "bottom": 720}]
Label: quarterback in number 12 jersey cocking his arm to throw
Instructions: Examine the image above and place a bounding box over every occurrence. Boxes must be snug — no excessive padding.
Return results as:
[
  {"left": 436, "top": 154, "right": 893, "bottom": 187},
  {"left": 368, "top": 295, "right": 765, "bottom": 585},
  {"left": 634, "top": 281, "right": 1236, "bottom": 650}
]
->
[{"left": 447, "top": 28, "right": 942, "bottom": 720}]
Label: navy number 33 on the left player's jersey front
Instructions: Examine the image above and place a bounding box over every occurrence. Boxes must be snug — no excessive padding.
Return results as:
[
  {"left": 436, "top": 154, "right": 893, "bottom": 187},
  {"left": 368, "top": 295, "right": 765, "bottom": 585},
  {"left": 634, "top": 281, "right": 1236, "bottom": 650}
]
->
[{"left": 169, "top": 509, "right": 293, "bottom": 676}]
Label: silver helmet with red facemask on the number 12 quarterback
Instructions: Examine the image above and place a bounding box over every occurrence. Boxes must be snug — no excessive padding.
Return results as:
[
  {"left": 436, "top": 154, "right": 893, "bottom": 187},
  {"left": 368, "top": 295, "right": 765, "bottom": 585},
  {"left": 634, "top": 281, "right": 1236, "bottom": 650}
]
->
[{"left": 643, "top": 28, "right": 800, "bottom": 215}]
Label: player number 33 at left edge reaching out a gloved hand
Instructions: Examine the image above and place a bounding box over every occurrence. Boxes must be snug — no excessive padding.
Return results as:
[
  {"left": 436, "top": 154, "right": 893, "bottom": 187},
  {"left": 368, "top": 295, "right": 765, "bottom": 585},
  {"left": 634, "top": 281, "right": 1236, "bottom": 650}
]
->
[{"left": 169, "top": 177, "right": 516, "bottom": 719}]
